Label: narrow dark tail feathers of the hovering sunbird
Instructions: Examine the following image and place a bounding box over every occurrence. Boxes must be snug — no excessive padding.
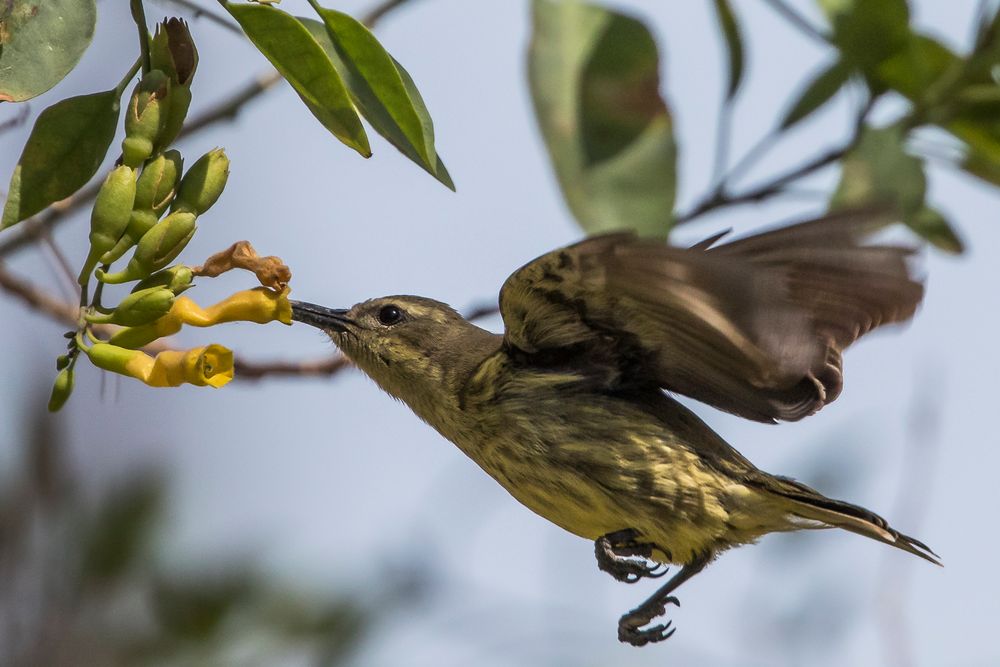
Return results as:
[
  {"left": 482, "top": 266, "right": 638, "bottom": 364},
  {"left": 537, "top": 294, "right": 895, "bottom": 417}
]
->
[{"left": 769, "top": 477, "right": 941, "bottom": 565}]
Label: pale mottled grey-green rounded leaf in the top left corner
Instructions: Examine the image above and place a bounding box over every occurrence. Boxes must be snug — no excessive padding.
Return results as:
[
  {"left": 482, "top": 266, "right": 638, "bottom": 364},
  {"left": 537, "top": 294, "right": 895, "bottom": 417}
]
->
[{"left": 0, "top": 0, "right": 97, "bottom": 102}]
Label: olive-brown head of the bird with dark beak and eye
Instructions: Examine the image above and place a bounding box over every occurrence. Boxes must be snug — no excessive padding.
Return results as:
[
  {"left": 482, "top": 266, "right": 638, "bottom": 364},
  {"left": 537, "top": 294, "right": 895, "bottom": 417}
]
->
[{"left": 292, "top": 296, "right": 491, "bottom": 409}]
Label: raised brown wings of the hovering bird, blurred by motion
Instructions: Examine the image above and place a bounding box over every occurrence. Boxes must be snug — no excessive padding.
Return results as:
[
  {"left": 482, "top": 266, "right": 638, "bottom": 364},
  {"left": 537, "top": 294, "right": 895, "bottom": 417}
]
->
[{"left": 500, "top": 210, "right": 923, "bottom": 422}]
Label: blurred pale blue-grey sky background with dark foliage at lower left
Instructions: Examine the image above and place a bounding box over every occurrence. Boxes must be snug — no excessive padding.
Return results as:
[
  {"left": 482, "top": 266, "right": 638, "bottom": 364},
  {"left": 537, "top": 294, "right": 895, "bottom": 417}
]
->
[{"left": 0, "top": 0, "right": 1000, "bottom": 667}]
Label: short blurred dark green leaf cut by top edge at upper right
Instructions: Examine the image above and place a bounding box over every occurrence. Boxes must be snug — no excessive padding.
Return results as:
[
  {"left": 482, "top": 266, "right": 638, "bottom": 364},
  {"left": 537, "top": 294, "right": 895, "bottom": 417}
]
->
[{"left": 819, "top": 0, "right": 911, "bottom": 74}]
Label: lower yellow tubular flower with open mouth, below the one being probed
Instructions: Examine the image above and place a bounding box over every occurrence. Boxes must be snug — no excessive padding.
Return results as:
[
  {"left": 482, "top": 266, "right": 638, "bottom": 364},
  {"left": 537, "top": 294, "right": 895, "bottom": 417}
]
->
[{"left": 85, "top": 343, "right": 233, "bottom": 387}]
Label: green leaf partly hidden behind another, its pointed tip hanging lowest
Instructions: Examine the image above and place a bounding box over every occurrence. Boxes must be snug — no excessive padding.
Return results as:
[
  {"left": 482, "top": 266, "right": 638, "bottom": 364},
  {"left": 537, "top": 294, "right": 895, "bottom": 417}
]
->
[{"left": 298, "top": 18, "right": 455, "bottom": 190}]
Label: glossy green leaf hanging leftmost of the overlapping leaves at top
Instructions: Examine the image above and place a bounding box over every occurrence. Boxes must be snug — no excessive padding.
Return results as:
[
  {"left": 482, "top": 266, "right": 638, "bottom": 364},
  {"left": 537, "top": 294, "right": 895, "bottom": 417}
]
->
[{"left": 222, "top": 2, "right": 372, "bottom": 157}]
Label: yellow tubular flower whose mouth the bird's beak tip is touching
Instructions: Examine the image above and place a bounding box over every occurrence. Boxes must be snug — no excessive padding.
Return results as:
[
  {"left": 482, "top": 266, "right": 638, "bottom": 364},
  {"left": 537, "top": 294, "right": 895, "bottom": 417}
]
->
[{"left": 108, "top": 287, "right": 292, "bottom": 348}]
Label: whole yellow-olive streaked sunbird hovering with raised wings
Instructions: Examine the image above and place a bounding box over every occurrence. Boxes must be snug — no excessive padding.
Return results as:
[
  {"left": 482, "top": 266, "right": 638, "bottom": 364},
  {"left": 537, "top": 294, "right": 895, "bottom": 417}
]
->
[{"left": 292, "top": 210, "right": 941, "bottom": 646}]
